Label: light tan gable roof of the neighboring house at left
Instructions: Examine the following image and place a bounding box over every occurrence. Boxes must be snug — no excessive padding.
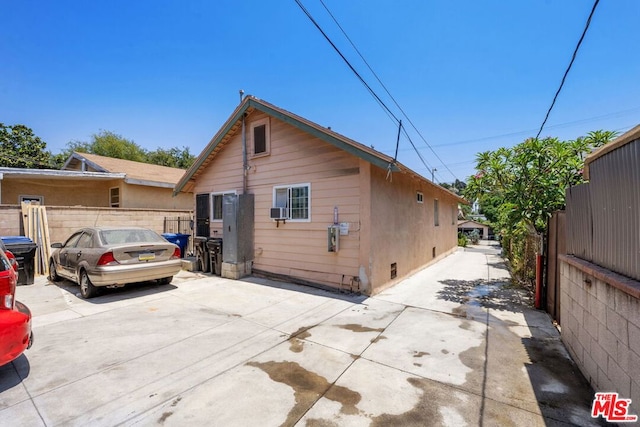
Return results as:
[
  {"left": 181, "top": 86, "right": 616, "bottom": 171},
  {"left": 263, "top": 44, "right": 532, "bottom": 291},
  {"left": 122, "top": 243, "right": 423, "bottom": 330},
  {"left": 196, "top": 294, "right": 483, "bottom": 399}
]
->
[{"left": 62, "top": 152, "right": 185, "bottom": 188}]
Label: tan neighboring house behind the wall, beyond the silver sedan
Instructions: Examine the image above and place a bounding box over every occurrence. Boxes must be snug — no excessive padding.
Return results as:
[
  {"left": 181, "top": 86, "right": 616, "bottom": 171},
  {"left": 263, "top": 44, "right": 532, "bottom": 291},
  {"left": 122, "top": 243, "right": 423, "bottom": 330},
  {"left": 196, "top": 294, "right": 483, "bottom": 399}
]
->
[{"left": 0, "top": 153, "right": 193, "bottom": 210}]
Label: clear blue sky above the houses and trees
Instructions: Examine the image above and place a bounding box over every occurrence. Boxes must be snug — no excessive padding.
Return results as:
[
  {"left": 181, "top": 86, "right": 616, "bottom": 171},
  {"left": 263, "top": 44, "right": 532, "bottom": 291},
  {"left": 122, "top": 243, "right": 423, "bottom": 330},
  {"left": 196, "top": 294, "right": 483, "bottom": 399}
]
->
[{"left": 0, "top": 0, "right": 640, "bottom": 182}]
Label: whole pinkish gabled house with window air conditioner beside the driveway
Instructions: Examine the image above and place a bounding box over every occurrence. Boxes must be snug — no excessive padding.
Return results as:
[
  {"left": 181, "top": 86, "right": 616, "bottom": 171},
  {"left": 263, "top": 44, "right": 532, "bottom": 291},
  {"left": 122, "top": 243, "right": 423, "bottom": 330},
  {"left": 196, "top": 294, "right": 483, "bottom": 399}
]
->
[{"left": 175, "top": 96, "right": 466, "bottom": 294}]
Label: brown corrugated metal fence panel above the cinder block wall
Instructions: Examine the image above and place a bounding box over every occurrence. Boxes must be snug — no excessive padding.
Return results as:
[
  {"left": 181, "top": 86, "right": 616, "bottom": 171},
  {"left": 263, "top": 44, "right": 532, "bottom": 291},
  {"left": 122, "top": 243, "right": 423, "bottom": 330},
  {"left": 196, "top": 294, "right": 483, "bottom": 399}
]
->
[{"left": 567, "top": 140, "right": 640, "bottom": 280}]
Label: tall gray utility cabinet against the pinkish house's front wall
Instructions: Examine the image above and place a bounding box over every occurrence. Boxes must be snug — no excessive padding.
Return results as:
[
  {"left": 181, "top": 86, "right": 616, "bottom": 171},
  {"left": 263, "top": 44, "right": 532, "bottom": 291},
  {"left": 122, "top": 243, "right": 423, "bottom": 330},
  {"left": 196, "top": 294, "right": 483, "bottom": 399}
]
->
[{"left": 222, "top": 194, "right": 254, "bottom": 264}]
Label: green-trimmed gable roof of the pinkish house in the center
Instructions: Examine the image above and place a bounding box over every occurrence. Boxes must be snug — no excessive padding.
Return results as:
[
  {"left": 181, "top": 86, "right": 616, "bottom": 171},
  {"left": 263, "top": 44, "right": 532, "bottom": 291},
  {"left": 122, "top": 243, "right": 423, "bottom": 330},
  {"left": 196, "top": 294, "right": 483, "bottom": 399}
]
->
[{"left": 173, "top": 95, "right": 466, "bottom": 203}]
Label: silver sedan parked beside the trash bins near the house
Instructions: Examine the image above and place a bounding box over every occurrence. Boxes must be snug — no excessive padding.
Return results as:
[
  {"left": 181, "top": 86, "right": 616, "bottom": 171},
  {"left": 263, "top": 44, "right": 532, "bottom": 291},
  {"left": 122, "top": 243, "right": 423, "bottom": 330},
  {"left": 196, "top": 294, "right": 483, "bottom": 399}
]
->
[{"left": 49, "top": 227, "right": 182, "bottom": 298}]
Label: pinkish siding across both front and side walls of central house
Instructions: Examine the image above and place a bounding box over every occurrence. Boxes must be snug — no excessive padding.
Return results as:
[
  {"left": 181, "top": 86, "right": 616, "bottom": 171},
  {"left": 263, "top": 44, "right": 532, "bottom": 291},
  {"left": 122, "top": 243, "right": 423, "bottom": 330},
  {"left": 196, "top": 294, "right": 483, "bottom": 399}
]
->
[{"left": 194, "top": 110, "right": 458, "bottom": 294}]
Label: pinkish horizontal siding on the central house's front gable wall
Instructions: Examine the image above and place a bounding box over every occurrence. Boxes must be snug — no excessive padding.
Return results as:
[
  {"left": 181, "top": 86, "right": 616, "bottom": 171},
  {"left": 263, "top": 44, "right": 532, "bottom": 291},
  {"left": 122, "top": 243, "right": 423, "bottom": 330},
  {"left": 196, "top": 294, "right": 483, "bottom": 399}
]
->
[{"left": 194, "top": 113, "right": 360, "bottom": 287}]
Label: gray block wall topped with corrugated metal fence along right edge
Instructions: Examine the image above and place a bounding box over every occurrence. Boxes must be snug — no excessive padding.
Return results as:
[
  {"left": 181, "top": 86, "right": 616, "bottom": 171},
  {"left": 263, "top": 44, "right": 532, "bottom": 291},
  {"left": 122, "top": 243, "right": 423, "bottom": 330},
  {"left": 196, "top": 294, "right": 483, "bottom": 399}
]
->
[{"left": 559, "top": 126, "right": 640, "bottom": 415}]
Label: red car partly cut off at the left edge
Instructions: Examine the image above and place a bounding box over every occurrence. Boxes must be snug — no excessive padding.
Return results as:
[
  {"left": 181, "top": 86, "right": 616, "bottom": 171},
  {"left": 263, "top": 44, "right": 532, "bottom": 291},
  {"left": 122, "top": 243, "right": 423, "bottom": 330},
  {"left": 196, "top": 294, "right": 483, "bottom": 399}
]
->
[{"left": 0, "top": 243, "right": 33, "bottom": 366}]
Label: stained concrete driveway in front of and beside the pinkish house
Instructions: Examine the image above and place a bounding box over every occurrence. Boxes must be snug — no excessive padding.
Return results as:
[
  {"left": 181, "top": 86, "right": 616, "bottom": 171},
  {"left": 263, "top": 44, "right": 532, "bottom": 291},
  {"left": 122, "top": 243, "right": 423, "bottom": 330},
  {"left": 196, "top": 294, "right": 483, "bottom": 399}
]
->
[{"left": 0, "top": 246, "right": 597, "bottom": 426}]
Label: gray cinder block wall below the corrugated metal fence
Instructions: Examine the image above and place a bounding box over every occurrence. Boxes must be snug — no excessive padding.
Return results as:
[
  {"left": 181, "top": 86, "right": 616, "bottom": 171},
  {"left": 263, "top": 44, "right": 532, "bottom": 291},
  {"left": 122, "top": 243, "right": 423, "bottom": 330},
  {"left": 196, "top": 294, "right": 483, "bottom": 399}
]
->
[{"left": 560, "top": 257, "right": 640, "bottom": 415}]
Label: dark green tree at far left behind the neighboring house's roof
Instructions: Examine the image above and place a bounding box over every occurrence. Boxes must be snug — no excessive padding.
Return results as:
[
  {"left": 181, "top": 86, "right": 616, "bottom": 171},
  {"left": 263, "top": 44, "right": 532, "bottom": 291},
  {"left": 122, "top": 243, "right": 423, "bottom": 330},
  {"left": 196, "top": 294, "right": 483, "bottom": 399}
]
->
[{"left": 0, "top": 123, "right": 51, "bottom": 169}]
